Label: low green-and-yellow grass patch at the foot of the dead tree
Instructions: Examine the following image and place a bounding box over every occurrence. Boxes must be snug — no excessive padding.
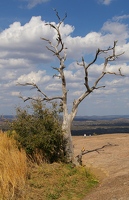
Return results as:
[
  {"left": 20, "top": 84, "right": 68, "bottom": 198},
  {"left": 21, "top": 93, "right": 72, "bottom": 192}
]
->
[{"left": 26, "top": 163, "right": 98, "bottom": 200}]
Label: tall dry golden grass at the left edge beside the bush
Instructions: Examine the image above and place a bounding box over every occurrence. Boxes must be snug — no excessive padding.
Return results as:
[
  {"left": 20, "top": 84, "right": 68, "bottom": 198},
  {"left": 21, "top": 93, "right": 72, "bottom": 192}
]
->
[{"left": 0, "top": 131, "right": 27, "bottom": 200}]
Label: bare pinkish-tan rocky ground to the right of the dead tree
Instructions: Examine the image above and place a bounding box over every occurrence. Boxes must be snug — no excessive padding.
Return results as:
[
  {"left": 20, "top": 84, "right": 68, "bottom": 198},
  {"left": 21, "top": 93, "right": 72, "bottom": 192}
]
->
[{"left": 73, "top": 134, "right": 129, "bottom": 200}]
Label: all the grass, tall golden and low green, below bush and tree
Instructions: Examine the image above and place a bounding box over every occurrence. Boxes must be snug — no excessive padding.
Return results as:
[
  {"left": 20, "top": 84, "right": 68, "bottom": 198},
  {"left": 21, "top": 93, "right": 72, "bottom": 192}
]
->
[{"left": 0, "top": 132, "right": 98, "bottom": 200}]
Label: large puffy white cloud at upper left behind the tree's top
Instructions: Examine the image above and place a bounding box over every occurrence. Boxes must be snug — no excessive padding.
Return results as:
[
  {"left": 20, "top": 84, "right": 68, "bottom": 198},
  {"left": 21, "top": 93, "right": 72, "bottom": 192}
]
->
[{"left": 0, "top": 16, "right": 74, "bottom": 63}]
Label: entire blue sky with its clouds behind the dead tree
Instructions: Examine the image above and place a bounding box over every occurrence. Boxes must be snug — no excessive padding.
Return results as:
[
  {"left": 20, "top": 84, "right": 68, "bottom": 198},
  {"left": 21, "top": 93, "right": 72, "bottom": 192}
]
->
[{"left": 0, "top": 0, "right": 129, "bottom": 115}]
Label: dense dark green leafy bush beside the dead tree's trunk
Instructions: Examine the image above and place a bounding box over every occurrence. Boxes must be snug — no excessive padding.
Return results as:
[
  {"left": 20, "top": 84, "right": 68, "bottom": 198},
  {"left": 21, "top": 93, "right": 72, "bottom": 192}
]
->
[{"left": 11, "top": 101, "right": 65, "bottom": 163}]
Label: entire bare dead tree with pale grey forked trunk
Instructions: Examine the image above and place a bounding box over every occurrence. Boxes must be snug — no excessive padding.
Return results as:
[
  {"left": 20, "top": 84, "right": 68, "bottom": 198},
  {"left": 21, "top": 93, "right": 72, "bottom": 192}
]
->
[{"left": 17, "top": 10, "right": 124, "bottom": 163}]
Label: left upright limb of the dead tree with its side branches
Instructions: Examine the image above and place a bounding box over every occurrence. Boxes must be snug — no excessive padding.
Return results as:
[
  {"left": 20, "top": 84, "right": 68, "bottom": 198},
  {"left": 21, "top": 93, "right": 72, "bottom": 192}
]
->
[{"left": 18, "top": 9, "right": 67, "bottom": 110}]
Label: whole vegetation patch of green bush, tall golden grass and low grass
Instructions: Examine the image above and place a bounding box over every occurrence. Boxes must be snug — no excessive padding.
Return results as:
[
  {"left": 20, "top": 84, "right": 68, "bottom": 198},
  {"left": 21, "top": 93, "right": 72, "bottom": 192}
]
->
[{"left": 0, "top": 101, "right": 98, "bottom": 200}]
